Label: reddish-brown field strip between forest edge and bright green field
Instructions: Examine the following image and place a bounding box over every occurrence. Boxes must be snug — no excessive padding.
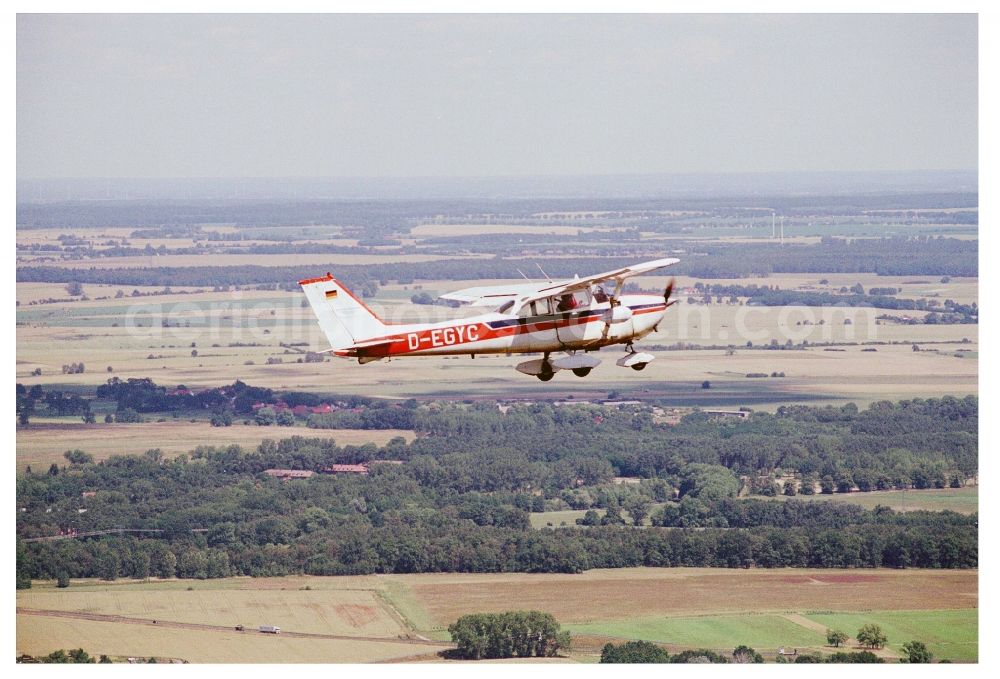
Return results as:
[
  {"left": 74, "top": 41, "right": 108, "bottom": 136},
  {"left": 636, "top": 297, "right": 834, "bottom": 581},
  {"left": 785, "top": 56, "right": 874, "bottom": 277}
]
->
[{"left": 402, "top": 568, "right": 978, "bottom": 626}]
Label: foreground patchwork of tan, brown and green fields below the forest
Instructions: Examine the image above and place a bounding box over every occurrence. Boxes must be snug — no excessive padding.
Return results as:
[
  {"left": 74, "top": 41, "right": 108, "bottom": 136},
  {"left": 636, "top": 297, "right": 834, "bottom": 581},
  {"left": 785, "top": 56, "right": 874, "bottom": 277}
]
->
[{"left": 17, "top": 568, "right": 978, "bottom": 662}]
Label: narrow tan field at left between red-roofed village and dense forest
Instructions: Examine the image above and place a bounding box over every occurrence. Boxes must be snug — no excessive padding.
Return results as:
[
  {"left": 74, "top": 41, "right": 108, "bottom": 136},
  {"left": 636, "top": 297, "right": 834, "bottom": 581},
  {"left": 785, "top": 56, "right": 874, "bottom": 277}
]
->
[{"left": 16, "top": 418, "right": 414, "bottom": 471}]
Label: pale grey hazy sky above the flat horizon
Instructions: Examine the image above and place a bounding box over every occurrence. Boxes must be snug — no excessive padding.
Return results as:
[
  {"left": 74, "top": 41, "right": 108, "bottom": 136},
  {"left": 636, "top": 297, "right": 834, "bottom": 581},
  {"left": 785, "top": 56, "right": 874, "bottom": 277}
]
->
[{"left": 17, "top": 15, "right": 978, "bottom": 178}]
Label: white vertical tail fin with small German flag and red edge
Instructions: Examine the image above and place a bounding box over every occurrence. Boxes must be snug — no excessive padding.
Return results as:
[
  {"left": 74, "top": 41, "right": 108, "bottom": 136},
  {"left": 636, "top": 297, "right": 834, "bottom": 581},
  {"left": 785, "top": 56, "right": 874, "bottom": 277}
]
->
[{"left": 299, "top": 274, "right": 386, "bottom": 349}]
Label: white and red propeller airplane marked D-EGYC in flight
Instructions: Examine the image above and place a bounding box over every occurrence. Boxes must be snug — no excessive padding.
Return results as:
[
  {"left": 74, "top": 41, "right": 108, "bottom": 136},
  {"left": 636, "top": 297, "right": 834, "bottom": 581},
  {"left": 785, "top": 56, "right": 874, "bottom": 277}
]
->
[{"left": 299, "top": 258, "right": 680, "bottom": 382}]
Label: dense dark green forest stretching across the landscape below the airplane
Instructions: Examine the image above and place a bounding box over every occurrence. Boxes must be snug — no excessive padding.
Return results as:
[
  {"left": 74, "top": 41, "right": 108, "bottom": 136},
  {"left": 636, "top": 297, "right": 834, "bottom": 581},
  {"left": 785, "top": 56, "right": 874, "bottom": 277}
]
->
[{"left": 17, "top": 396, "right": 978, "bottom": 586}]
